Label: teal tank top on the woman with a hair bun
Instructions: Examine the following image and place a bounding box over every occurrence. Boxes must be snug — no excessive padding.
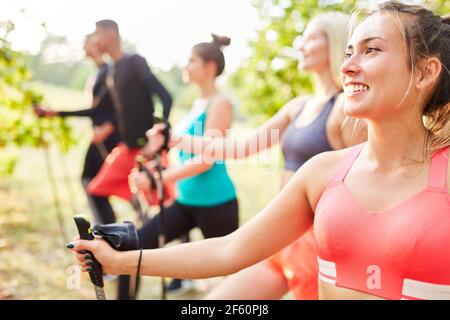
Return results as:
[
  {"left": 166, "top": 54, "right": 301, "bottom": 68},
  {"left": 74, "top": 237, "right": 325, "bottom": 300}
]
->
[{"left": 175, "top": 99, "right": 236, "bottom": 207}]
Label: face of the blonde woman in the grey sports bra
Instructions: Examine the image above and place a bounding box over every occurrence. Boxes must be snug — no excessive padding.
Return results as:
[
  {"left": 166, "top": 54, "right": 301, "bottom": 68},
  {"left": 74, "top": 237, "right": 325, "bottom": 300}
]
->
[{"left": 299, "top": 20, "right": 329, "bottom": 72}]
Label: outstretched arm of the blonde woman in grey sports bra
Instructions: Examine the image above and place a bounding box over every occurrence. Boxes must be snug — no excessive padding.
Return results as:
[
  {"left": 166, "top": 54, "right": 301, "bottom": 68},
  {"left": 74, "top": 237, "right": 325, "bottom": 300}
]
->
[{"left": 147, "top": 97, "right": 307, "bottom": 160}]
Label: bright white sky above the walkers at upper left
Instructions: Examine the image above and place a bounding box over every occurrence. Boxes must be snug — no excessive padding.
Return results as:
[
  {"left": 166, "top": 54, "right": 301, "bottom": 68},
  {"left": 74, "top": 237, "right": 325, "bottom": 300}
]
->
[{"left": 0, "top": 0, "right": 258, "bottom": 70}]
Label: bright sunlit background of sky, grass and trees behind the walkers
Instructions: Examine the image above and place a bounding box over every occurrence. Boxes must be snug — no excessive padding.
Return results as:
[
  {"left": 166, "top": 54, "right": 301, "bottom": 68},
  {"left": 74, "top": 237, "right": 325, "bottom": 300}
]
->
[{"left": 0, "top": 0, "right": 450, "bottom": 299}]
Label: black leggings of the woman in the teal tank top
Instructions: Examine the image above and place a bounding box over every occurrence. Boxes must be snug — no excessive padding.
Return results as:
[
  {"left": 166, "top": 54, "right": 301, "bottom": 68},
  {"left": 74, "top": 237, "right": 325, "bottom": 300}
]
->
[{"left": 117, "top": 199, "right": 239, "bottom": 300}]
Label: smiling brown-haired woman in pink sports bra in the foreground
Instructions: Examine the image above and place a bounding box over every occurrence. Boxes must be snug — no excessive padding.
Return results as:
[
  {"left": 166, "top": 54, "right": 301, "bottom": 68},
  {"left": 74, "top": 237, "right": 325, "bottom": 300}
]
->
[{"left": 71, "top": 2, "right": 450, "bottom": 299}]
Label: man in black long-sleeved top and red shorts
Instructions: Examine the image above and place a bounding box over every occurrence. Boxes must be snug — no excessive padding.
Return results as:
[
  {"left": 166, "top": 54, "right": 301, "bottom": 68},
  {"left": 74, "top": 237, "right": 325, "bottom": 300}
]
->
[{"left": 89, "top": 20, "right": 172, "bottom": 204}]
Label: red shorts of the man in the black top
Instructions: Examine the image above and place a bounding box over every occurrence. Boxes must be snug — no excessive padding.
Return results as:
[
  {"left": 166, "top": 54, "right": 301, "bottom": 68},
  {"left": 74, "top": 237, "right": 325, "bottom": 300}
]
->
[{"left": 88, "top": 143, "right": 174, "bottom": 204}]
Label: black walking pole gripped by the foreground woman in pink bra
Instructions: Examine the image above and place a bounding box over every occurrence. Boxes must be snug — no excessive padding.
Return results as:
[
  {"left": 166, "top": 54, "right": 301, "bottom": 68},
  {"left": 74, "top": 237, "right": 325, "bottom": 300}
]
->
[{"left": 73, "top": 214, "right": 106, "bottom": 300}]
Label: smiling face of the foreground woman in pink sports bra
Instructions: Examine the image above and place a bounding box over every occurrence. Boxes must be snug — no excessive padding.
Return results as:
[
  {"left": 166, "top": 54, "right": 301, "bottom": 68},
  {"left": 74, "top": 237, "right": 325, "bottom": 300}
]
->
[{"left": 341, "top": 13, "right": 414, "bottom": 118}]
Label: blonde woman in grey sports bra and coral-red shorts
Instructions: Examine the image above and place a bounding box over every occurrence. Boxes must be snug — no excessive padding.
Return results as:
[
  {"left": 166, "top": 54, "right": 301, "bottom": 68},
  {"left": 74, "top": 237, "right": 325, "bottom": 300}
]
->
[{"left": 147, "top": 11, "right": 367, "bottom": 300}]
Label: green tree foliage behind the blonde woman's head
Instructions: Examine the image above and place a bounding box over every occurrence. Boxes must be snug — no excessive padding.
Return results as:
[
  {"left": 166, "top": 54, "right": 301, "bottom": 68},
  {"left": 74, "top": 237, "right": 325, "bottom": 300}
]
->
[{"left": 232, "top": 0, "right": 450, "bottom": 118}]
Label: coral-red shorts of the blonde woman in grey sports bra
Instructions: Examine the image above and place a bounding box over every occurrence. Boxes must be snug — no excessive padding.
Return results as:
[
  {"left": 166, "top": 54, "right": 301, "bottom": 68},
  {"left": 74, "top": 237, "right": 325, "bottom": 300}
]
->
[{"left": 266, "top": 227, "right": 319, "bottom": 300}]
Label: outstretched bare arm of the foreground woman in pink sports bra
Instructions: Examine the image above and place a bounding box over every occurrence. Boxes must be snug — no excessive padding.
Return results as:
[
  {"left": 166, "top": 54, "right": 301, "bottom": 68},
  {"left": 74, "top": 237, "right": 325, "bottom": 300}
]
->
[{"left": 68, "top": 151, "right": 340, "bottom": 279}]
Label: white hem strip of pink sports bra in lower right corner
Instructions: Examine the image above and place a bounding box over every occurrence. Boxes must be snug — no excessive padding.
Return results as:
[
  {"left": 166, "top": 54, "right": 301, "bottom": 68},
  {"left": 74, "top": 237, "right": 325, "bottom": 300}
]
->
[{"left": 402, "top": 279, "right": 450, "bottom": 300}]
